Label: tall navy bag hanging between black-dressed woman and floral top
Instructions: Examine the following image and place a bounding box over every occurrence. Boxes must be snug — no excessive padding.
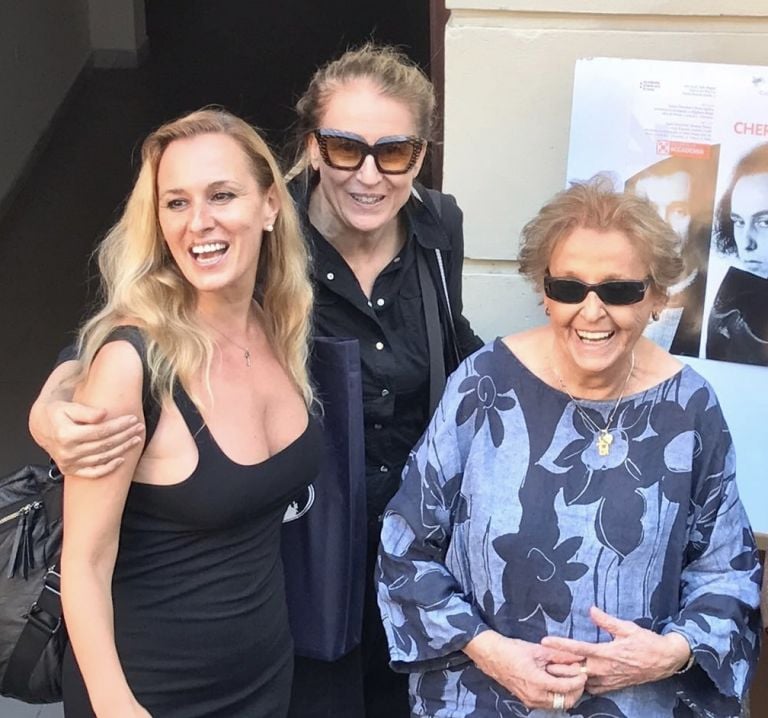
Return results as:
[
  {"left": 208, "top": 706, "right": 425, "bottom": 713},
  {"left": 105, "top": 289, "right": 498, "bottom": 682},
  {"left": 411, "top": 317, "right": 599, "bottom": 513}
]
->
[{"left": 282, "top": 337, "right": 366, "bottom": 661}]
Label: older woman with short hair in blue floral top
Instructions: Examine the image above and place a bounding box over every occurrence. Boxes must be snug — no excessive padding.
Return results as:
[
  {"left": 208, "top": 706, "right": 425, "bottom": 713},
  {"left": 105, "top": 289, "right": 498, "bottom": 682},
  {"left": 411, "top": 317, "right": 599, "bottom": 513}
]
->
[{"left": 379, "top": 181, "right": 761, "bottom": 718}]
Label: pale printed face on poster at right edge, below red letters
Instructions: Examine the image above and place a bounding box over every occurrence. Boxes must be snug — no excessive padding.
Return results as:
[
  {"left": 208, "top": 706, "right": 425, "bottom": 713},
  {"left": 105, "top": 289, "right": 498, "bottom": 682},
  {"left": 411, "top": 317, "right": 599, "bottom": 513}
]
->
[{"left": 731, "top": 173, "right": 768, "bottom": 278}]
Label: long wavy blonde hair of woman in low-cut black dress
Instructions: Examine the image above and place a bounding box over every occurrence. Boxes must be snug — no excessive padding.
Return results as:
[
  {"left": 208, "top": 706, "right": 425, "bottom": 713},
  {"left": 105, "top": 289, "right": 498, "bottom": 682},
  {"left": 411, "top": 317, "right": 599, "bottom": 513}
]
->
[{"left": 78, "top": 108, "right": 313, "bottom": 406}]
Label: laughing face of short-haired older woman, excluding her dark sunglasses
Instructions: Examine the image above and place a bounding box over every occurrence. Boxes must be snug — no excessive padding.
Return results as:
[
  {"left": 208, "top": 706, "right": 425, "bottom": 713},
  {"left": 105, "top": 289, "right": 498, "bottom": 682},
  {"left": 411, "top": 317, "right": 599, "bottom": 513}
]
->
[{"left": 545, "top": 227, "right": 664, "bottom": 393}]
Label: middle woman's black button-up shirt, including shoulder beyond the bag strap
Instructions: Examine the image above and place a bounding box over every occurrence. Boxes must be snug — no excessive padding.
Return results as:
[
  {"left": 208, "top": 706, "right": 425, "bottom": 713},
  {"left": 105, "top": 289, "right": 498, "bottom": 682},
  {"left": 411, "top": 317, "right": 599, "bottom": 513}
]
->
[{"left": 291, "top": 181, "right": 482, "bottom": 523}]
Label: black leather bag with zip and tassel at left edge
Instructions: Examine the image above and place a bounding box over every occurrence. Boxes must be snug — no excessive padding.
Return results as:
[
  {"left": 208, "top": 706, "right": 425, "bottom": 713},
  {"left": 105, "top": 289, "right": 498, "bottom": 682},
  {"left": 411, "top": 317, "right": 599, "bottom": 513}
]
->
[{"left": 0, "top": 465, "right": 67, "bottom": 703}]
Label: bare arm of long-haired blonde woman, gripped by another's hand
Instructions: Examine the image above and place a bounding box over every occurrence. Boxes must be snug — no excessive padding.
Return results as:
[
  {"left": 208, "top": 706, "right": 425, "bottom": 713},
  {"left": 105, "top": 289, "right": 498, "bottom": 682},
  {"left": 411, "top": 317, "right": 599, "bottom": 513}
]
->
[{"left": 62, "top": 341, "right": 154, "bottom": 718}]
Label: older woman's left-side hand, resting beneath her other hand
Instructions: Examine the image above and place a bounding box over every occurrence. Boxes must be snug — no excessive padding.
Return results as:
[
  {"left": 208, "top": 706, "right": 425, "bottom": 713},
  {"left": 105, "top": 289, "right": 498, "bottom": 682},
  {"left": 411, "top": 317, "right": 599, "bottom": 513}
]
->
[{"left": 464, "top": 631, "right": 586, "bottom": 710}]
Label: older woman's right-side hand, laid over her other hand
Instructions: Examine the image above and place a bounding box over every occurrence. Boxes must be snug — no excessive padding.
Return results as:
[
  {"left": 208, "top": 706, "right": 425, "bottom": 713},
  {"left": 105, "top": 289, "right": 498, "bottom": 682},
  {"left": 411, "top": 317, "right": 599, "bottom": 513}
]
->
[{"left": 541, "top": 606, "right": 690, "bottom": 695}]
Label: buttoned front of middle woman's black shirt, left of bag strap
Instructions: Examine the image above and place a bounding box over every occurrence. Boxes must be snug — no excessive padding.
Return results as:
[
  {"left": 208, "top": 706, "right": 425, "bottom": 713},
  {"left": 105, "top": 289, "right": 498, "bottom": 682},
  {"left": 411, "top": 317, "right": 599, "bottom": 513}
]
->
[{"left": 310, "top": 222, "right": 429, "bottom": 518}]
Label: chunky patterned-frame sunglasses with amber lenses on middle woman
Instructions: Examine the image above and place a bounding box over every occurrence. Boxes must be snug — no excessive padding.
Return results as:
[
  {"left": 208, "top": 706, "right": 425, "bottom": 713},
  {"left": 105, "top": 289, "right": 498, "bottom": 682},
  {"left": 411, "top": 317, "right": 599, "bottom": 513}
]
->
[{"left": 314, "top": 130, "right": 425, "bottom": 175}]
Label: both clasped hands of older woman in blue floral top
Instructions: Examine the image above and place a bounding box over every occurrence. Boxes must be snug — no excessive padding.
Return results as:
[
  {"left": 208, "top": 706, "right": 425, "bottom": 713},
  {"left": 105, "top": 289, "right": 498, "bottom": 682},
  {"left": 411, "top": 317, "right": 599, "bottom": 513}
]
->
[{"left": 465, "top": 607, "right": 690, "bottom": 710}]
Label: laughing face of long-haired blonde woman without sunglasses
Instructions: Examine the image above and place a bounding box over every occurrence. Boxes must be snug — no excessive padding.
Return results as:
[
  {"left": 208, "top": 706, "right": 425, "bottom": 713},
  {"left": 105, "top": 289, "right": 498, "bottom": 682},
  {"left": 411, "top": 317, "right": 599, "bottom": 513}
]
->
[{"left": 157, "top": 133, "right": 278, "bottom": 296}]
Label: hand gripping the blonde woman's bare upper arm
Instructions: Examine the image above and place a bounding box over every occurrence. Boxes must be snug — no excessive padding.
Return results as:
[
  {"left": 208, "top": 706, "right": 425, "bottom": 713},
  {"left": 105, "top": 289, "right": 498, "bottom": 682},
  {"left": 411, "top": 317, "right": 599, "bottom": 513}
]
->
[{"left": 35, "top": 401, "right": 144, "bottom": 479}]
